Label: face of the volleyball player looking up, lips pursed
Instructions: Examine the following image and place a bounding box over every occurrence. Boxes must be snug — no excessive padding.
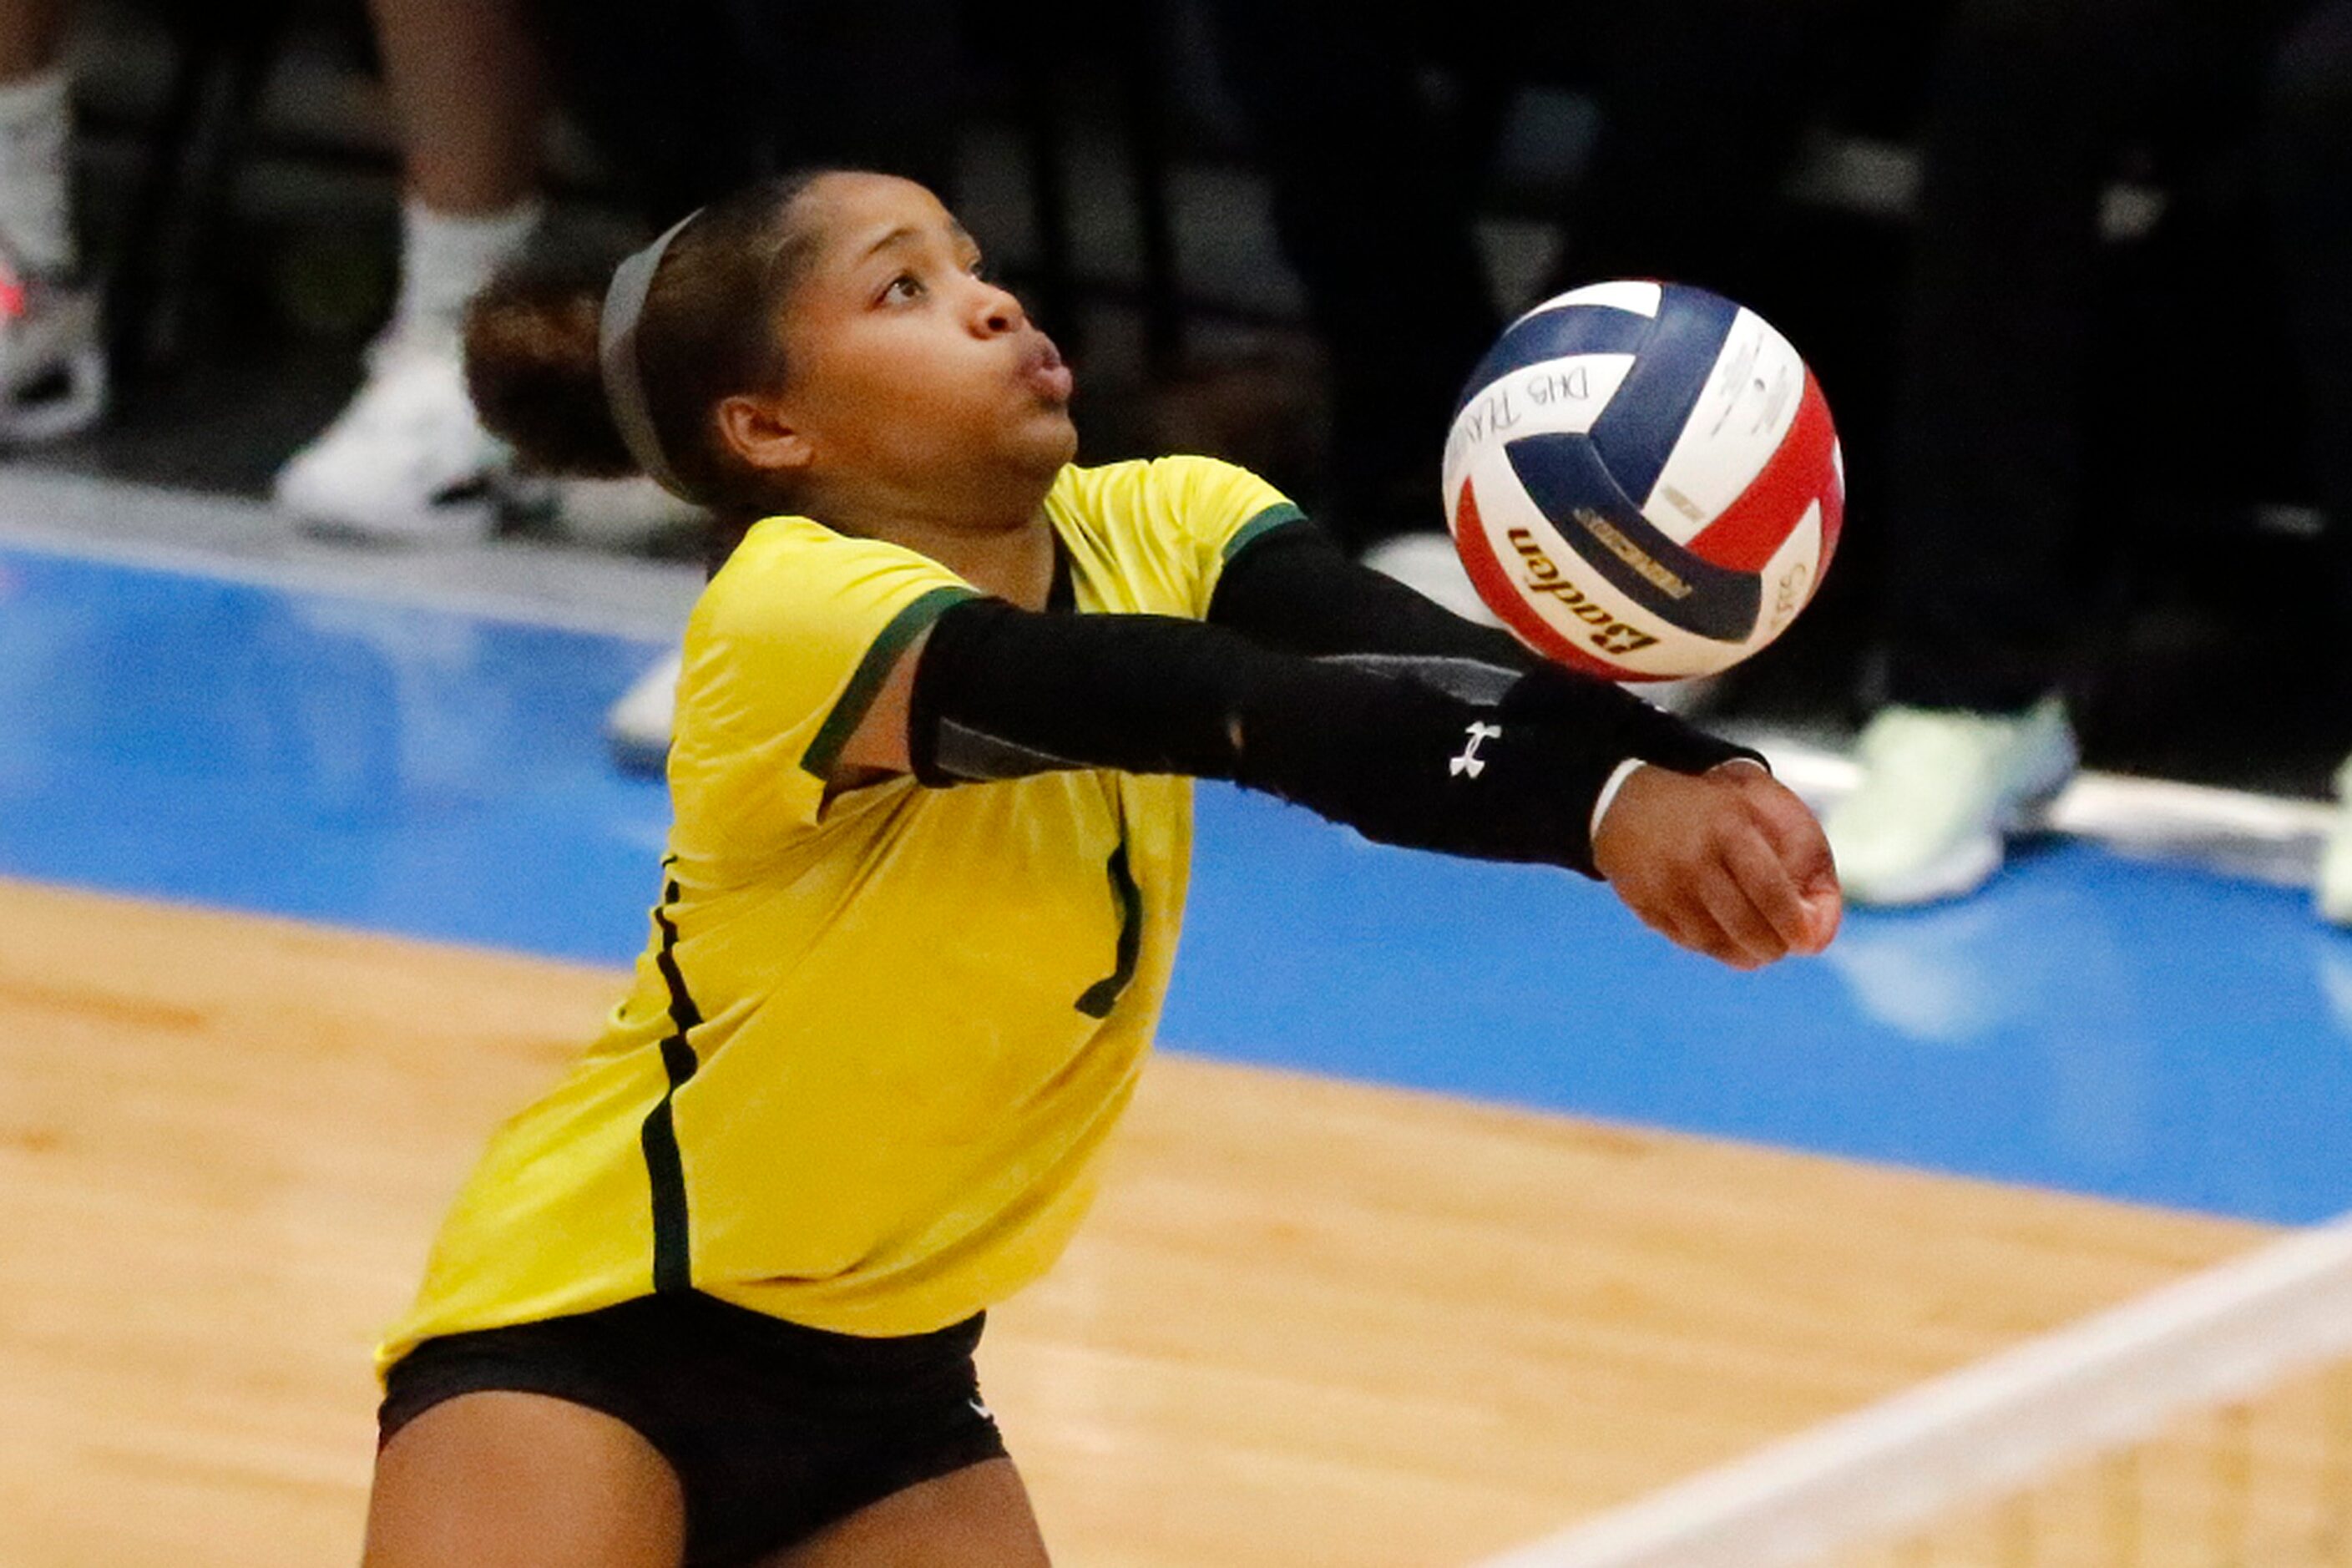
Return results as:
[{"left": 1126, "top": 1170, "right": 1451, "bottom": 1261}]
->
[{"left": 783, "top": 174, "right": 1077, "bottom": 500}]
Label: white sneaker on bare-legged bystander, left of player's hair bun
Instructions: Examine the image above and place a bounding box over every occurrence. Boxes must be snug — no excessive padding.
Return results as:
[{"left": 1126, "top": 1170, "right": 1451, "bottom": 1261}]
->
[{"left": 276, "top": 331, "right": 508, "bottom": 545}]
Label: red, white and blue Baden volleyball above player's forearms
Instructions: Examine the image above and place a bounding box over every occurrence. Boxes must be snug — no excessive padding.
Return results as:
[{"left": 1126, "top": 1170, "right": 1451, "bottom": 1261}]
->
[{"left": 1444, "top": 282, "right": 1846, "bottom": 682}]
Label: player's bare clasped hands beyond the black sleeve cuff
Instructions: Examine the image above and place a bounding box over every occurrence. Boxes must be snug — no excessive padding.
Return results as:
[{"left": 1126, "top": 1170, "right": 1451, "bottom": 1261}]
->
[{"left": 1592, "top": 761, "right": 1844, "bottom": 969}]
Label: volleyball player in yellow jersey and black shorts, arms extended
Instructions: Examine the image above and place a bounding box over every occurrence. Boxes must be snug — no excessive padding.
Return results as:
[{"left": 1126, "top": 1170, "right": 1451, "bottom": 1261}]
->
[{"left": 367, "top": 172, "right": 1839, "bottom": 1568}]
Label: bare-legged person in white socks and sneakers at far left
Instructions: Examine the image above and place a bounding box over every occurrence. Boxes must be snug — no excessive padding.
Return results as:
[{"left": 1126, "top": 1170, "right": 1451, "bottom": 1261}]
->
[{"left": 0, "top": 0, "right": 616, "bottom": 543}]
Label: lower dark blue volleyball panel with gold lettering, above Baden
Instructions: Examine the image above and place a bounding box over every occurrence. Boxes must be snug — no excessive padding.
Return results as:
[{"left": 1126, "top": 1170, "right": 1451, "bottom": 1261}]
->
[{"left": 1503, "top": 435, "right": 1764, "bottom": 642}]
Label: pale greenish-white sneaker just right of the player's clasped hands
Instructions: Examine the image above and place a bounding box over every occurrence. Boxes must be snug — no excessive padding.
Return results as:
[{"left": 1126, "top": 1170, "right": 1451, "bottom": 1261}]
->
[{"left": 1820, "top": 698, "right": 2081, "bottom": 905}]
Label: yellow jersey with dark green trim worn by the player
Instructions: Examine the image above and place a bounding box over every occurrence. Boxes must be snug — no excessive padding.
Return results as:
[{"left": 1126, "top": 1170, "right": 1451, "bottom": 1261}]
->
[{"left": 379, "top": 458, "right": 1298, "bottom": 1366}]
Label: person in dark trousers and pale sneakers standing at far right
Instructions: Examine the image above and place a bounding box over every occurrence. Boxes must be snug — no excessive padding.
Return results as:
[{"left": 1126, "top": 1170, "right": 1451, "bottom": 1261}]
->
[{"left": 1828, "top": 0, "right": 2352, "bottom": 922}]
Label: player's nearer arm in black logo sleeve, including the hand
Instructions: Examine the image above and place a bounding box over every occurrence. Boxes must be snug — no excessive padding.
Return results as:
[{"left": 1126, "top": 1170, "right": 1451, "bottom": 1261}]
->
[{"left": 842, "top": 552, "right": 1837, "bottom": 969}]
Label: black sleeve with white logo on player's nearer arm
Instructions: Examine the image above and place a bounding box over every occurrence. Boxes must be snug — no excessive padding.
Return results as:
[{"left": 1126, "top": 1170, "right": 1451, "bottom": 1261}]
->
[{"left": 908, "top": 599, "right": 1749, "bottom": 877}]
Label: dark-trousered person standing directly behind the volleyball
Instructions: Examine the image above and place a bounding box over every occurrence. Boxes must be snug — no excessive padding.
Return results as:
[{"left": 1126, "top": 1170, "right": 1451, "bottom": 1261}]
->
[{"left": 1209, "top": 0, "right": 1844, "bottom": 619}]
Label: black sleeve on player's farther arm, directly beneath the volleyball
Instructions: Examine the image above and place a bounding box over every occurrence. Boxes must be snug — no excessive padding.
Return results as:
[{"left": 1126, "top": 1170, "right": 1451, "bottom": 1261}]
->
[{"left": 1209, "top": 522, "right": 1764, "bottom": 773}]
